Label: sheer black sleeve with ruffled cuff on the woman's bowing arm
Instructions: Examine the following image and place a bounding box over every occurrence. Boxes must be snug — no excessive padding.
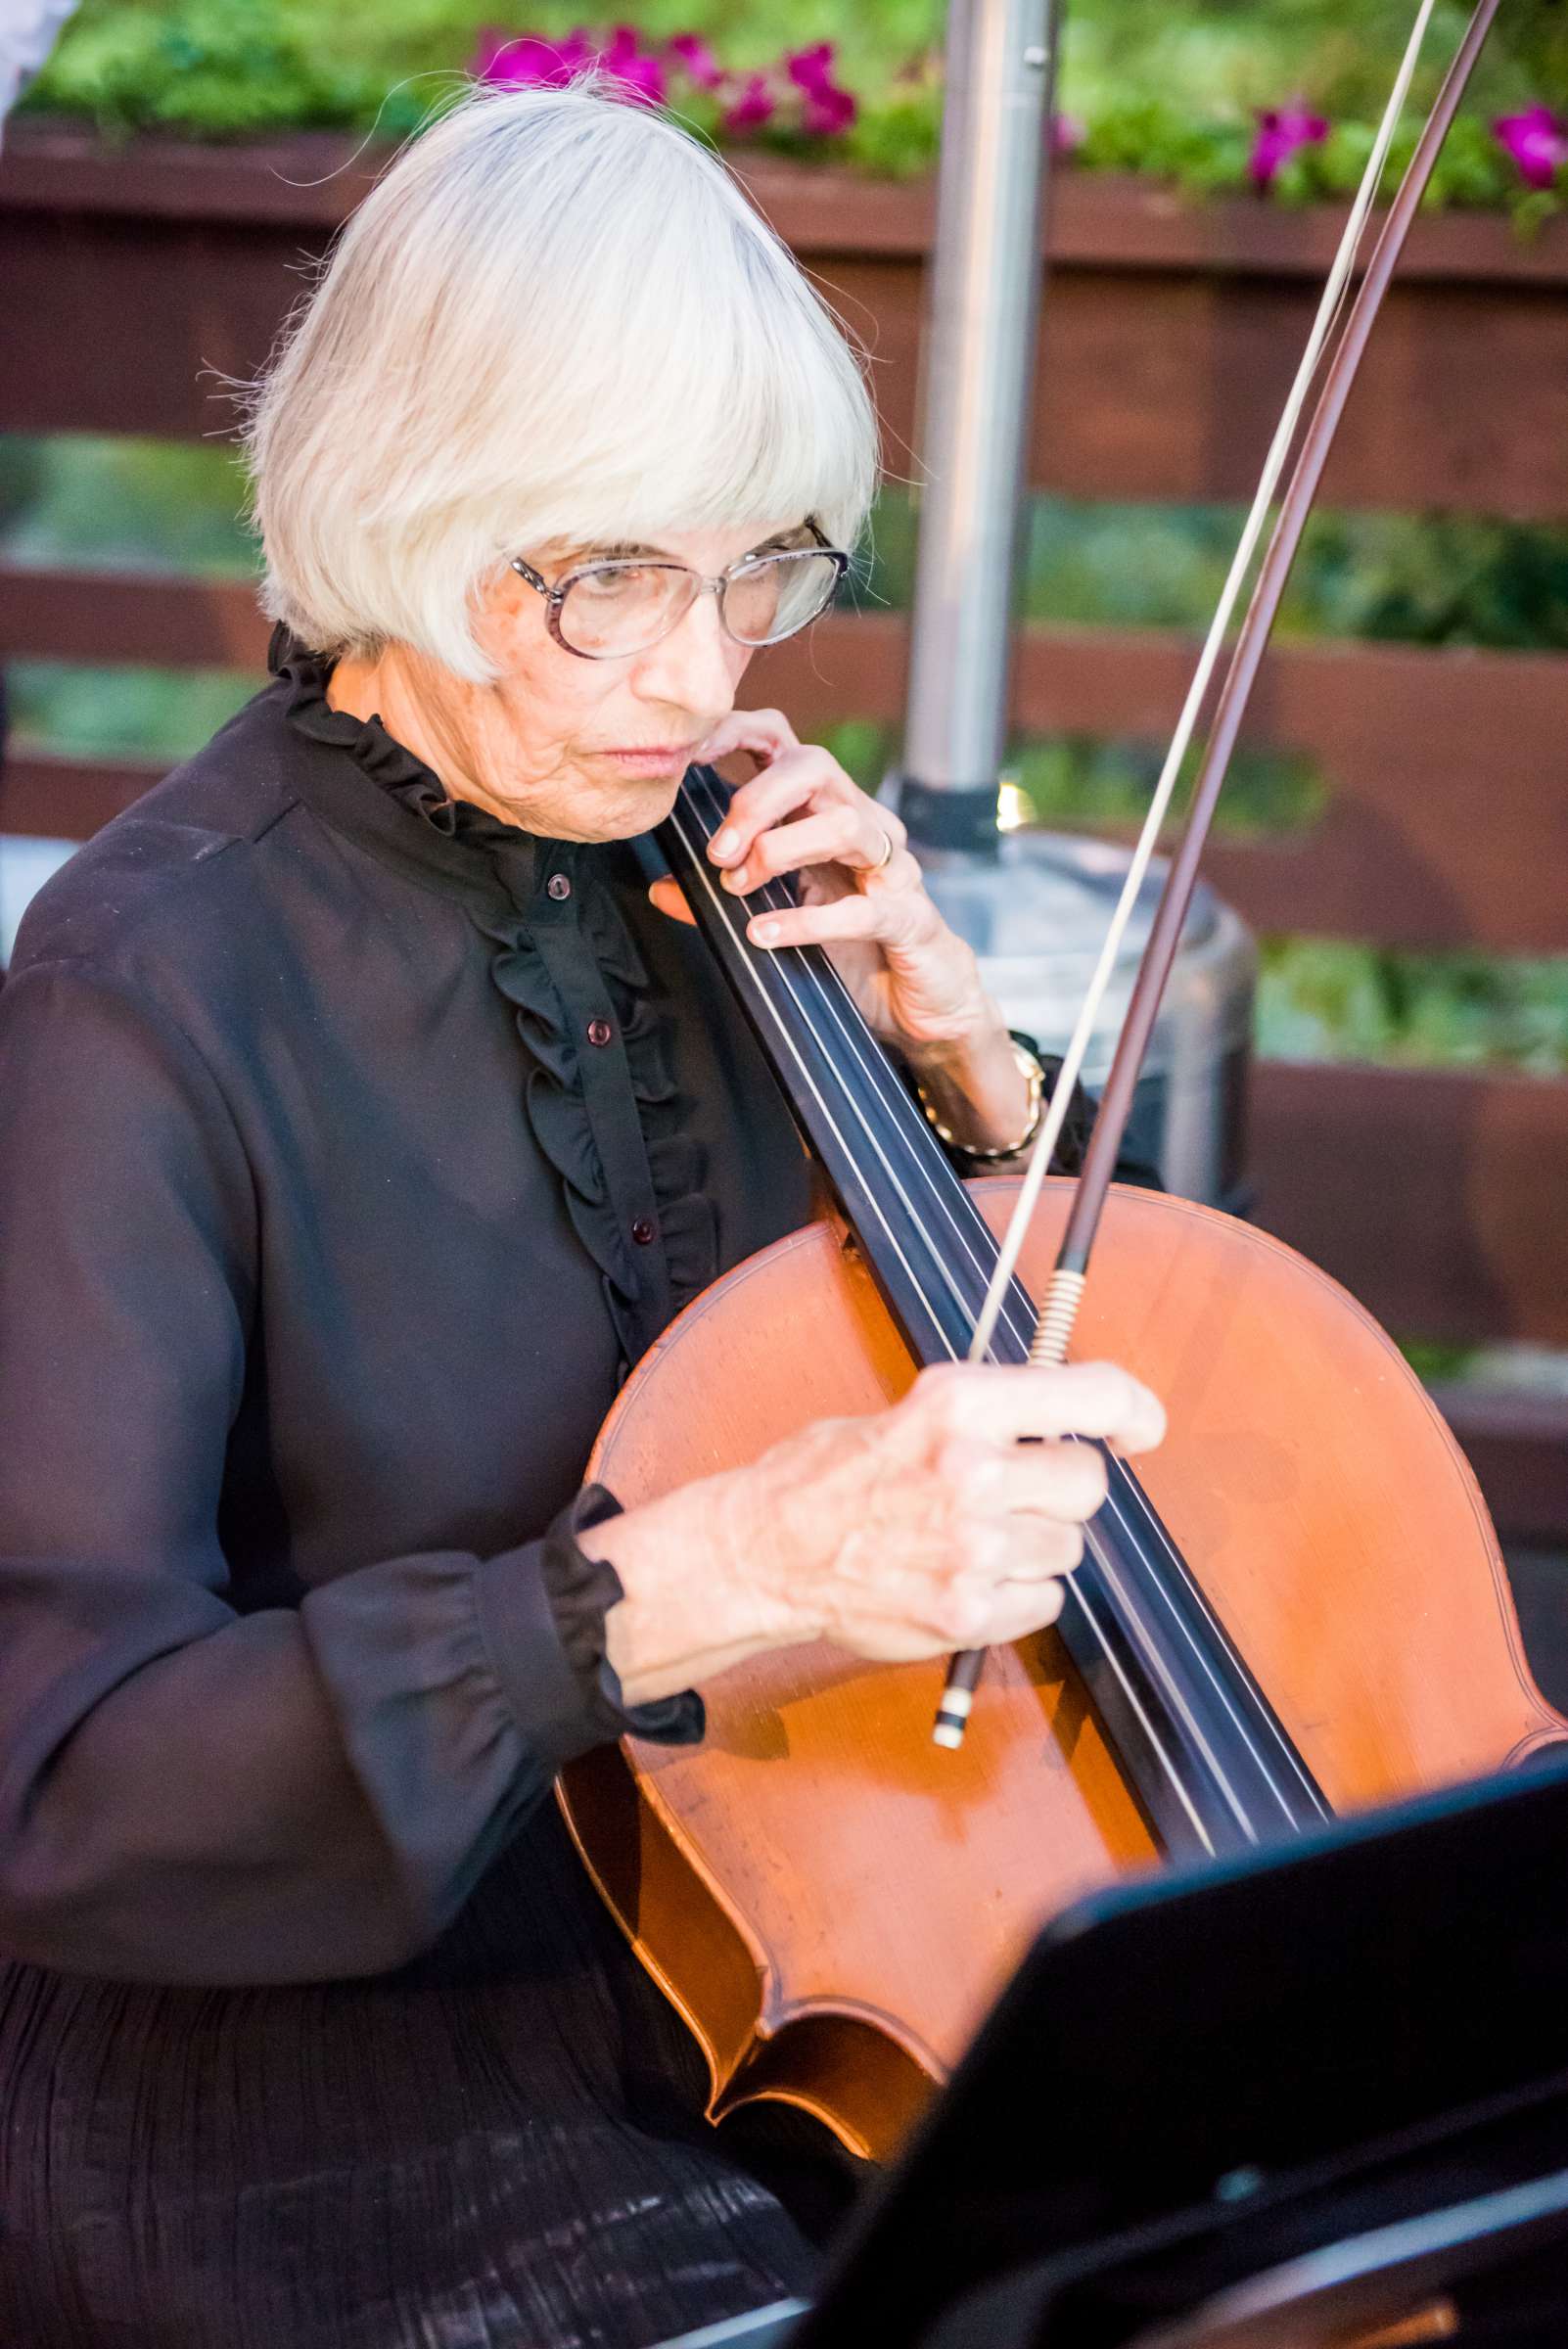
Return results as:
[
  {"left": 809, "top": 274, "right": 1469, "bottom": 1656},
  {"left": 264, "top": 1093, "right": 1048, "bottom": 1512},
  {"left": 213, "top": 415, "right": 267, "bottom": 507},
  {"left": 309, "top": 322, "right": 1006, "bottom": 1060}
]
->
[{"left": 0, "top": 963, "right": 702, "bottom": 1983}]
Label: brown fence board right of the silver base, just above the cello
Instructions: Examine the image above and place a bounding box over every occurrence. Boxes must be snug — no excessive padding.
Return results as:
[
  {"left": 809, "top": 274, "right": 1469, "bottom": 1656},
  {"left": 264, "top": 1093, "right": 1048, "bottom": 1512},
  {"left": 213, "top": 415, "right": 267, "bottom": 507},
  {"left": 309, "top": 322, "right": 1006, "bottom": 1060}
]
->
[{"left": 1249, "top": 1062, "right": 1568, "bottom": 1346}]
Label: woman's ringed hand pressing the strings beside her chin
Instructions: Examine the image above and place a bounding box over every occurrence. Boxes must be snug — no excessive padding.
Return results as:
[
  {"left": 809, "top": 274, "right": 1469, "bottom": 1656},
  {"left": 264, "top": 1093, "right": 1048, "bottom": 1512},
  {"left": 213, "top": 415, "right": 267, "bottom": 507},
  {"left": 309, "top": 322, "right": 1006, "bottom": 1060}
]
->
[{"left": 653, "top": 710, "right": 1000, "bottom": 1057}]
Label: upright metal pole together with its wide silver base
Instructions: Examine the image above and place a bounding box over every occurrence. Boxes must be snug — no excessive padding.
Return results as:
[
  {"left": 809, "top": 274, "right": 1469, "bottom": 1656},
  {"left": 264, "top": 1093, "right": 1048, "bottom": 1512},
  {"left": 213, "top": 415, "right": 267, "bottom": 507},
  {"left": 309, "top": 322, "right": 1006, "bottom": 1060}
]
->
[{"left": 885, "top": 0, "right": 1254, "bottom": 1205}]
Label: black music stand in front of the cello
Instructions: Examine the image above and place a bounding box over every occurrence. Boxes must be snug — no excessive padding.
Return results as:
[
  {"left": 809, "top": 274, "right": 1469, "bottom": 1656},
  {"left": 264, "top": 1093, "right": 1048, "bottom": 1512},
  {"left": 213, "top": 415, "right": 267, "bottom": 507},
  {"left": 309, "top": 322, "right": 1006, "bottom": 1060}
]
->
[{"left": 657, "top": 1760, "right": 1568, "bottom": 2349}]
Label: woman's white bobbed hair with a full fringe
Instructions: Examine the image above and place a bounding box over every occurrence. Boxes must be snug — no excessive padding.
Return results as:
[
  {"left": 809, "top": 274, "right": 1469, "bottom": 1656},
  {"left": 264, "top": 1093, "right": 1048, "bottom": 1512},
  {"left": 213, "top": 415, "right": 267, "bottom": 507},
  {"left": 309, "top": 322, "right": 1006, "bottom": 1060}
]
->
[{"left": 247, "top": 82, "right": 878, "bottom": 683}]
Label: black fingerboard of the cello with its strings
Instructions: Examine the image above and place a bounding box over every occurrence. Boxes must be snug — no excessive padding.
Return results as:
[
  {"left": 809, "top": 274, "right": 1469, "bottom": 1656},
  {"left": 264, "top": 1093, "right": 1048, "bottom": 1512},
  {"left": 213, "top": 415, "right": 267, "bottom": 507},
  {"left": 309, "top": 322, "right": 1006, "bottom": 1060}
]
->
[{"left": 660, "top": 768, "right": 1331, "bottom": 1858}]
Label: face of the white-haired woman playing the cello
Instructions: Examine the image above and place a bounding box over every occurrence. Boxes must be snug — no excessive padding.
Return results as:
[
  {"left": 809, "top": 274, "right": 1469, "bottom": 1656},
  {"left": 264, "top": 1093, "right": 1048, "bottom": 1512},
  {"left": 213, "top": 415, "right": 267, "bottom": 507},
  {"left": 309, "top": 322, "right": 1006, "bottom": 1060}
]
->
[{"left": 383, "top": 517, "right": 798, "bottom": 841}]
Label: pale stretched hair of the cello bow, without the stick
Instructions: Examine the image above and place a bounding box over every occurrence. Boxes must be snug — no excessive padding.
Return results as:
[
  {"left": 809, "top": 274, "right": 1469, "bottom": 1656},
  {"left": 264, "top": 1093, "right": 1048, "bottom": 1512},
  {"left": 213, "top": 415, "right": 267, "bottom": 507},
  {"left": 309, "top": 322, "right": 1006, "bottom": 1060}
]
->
[{"left": 969, "top": 0, "right": 1434, "bottom": 1360}]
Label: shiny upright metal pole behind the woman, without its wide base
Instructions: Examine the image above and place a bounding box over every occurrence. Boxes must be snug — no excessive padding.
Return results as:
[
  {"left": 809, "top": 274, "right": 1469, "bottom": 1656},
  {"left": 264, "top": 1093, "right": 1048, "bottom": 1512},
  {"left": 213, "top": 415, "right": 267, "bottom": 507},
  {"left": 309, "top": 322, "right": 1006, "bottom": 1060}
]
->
[{"left": 897, "top": 0, "right": 1061, "bottom": 855}]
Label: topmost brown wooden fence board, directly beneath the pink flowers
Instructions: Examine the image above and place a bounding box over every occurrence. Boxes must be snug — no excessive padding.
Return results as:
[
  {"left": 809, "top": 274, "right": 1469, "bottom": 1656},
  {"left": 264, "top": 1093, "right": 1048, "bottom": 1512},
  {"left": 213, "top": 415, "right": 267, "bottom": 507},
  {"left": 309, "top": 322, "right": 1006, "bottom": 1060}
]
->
[{"left": 0, "top": 124, "right": 1568, "bottom": 517}]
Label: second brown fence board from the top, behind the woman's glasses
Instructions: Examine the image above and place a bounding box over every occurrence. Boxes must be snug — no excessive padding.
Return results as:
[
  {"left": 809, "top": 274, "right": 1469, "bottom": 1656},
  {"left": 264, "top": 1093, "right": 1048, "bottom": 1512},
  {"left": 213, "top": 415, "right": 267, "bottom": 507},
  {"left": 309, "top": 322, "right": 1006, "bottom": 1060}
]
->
[{"left": 0, "top": 582, "right": 1568, "bottom": 953}]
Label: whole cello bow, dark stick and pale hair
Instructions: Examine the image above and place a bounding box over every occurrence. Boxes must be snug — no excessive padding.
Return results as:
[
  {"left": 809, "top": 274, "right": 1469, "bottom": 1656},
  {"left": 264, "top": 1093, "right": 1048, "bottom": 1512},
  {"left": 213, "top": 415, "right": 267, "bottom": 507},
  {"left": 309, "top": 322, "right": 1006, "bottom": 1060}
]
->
[{"left": 932, "top": 0, "right": 1499, "bottom": 1745}]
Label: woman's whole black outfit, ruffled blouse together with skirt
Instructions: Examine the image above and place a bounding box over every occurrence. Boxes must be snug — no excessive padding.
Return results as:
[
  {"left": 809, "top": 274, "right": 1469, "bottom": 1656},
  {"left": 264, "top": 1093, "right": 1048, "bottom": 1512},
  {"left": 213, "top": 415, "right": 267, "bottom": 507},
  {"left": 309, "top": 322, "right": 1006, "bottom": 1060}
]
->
[{"left": 0, "top": 632, "right": 1127, "bottom": 2349}]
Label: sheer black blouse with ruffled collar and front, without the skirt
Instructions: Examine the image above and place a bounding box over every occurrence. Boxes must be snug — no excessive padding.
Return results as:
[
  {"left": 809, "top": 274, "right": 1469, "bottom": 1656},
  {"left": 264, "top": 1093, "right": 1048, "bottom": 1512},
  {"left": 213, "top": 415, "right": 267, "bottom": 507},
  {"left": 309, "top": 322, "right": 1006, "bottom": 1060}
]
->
[{"left": 0, "top": 632, "right": 830, "bottom": 1983}]
